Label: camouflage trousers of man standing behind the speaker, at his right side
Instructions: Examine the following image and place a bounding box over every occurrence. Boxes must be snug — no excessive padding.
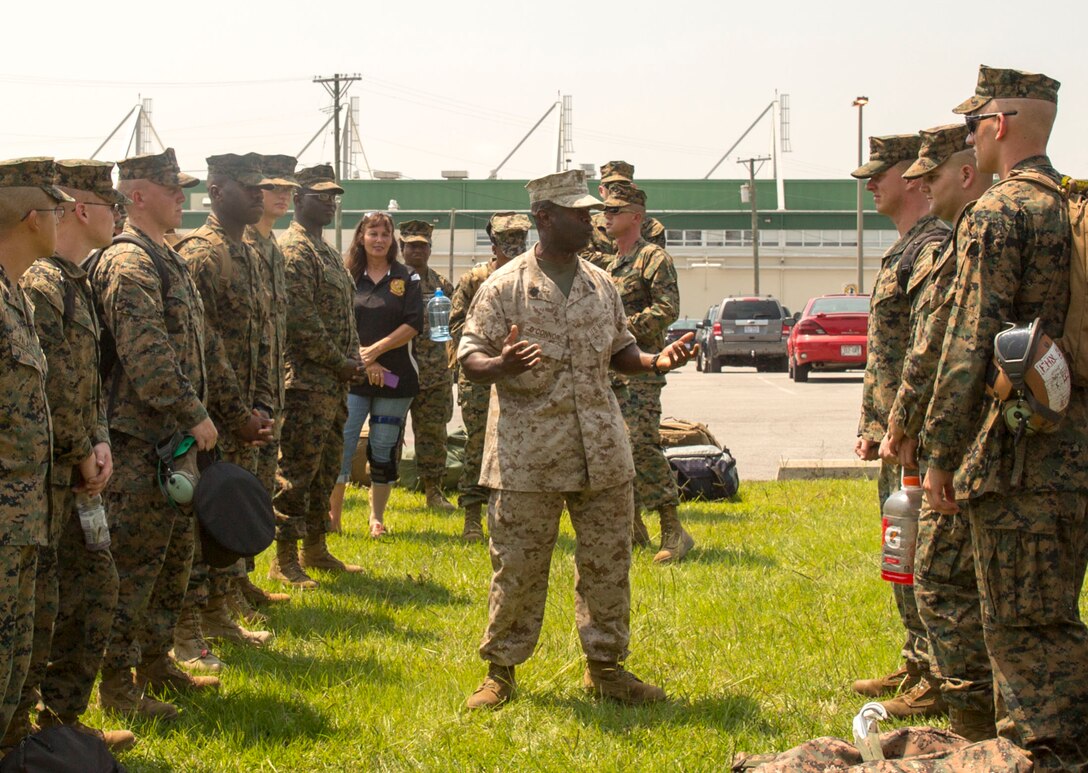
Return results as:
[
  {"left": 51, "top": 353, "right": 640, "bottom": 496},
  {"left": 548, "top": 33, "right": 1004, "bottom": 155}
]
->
[{"left": 613, "top": 379, "right": 680, "bottom": 512}]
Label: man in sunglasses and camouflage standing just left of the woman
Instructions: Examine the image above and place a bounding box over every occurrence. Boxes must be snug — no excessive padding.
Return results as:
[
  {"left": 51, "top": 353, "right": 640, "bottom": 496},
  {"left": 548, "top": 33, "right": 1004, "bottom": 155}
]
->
[{"left": 269, "top": 163, "right": 361, "bottom": 588}]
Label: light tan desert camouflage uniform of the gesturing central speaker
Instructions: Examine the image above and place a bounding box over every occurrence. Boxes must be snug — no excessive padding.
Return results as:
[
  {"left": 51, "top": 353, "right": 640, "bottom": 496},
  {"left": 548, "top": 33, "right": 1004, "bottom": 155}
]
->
[{"left": 458, "top": 250, "right": 634, "bottom": 666}]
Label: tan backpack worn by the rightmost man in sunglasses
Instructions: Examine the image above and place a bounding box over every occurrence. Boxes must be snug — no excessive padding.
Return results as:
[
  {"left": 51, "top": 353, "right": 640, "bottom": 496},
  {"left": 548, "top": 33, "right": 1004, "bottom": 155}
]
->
[{"left": 1006, "top": 171, "right": 1088, "bottom": 387}]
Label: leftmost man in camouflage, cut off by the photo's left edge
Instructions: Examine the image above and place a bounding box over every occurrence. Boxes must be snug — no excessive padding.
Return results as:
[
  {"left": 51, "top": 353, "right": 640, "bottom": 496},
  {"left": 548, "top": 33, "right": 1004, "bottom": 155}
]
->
[{"left": 0, "top": 158, "right": 63, "bottom": 751}]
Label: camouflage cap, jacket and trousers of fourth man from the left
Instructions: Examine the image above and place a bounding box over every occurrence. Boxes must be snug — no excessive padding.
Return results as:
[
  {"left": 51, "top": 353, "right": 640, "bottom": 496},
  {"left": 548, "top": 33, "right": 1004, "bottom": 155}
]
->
[{"left": 174, "top": 170, "right": 273, "bottom": 606}]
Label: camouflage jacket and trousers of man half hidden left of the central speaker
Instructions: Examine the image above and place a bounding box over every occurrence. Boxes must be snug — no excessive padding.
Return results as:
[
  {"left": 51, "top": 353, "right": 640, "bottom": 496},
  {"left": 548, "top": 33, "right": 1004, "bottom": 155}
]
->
[{"left": 449, "top": 263, "right": 493, "bottom": 507}]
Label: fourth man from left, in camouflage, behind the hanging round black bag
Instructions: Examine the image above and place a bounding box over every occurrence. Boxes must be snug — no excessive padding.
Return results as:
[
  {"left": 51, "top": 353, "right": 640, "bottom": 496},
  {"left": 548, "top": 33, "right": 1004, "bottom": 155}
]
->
[{"left": 174, "top": 154, "right": 273, "bottom": 665}]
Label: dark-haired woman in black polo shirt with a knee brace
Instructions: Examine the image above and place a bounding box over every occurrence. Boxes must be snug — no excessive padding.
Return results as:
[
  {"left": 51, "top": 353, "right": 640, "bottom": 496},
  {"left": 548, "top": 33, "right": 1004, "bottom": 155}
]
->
[{"left": 330, "top": 212, "right": 423, "bottom": 538}]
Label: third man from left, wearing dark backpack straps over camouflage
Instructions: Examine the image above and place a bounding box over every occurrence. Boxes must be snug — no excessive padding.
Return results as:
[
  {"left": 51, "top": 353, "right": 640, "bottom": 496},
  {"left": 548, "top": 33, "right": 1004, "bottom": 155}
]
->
[{"left": 89, "top": 148, "right": 227, "bottom": 719}]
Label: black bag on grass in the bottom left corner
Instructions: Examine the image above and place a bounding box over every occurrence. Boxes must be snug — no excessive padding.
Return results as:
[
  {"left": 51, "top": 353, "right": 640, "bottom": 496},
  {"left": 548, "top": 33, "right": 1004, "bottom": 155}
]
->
[{"left": 0, "top": 725, "right": 125, "bottom": 773}]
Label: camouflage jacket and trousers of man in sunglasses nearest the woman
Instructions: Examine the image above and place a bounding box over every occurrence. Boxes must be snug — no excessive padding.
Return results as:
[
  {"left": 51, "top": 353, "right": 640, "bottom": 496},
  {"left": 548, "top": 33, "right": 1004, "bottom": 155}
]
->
[{"left": 273, "top": 221, "right": 359, "bottom": 540}]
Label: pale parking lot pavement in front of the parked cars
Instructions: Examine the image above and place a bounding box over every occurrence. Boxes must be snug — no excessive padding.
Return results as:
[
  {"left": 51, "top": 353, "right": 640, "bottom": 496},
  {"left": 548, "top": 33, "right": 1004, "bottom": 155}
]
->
[{"left": 662, "top": 364, "right": 862, "bottom": 481}]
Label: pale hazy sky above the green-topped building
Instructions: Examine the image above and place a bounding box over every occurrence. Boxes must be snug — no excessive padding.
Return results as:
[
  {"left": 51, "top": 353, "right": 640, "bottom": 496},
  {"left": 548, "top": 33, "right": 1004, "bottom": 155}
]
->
[{"left": 0, "top": 0, "right": 1088, "bottom": 179}]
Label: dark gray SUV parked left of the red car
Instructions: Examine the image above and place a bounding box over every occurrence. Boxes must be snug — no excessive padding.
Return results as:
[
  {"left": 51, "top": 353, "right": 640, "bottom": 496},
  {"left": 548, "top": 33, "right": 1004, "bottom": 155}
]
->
[{"left": 704, "top": 296, "right": 789, "bottom": 373}]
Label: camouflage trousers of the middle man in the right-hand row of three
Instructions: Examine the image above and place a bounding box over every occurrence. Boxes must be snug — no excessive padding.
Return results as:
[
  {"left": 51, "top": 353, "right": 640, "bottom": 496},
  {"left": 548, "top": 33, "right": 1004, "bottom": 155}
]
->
[{"left": 914, "top": 503, "right": 993, "bottom": 712}]
